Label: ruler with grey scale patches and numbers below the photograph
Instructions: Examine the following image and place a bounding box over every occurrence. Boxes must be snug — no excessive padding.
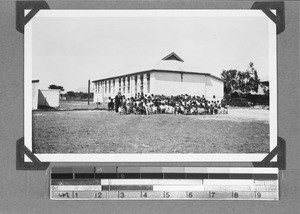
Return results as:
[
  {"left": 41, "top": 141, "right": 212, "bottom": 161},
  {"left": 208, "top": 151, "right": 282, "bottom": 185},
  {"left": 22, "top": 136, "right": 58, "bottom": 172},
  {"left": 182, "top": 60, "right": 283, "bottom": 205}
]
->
[{"left": 50, "top": 166, "right": 279, "bottom": 200}]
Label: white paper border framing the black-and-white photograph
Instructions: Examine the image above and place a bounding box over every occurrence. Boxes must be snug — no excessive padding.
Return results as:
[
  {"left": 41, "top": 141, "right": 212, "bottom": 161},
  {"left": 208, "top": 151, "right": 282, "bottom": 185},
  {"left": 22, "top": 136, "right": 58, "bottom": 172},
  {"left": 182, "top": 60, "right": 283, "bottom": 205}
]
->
[{"left": 24, "top": 9, "right": 277, "bottom": 163}]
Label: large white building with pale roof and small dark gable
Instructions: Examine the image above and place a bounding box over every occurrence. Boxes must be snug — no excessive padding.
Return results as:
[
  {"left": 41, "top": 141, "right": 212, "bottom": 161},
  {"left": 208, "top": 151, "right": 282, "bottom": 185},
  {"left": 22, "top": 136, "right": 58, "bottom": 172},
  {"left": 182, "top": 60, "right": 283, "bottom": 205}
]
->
[{"left": 93, "top": 52, "right": 224, "bottom": 102}]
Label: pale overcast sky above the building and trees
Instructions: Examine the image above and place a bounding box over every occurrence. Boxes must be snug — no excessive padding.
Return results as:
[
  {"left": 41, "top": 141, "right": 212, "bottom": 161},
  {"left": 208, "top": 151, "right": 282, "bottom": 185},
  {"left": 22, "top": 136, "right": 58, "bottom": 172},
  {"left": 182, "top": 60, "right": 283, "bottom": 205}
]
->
[{"left": 32, "top": 11, "right": 269, "bottom": 91}]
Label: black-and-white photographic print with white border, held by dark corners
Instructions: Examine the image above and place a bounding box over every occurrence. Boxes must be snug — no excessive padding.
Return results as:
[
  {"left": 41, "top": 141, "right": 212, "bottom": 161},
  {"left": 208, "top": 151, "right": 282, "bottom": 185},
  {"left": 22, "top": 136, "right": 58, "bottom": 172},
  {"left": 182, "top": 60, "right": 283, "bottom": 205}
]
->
[{"left": 24, "top": 10, "right": 277, "bottom": 162}]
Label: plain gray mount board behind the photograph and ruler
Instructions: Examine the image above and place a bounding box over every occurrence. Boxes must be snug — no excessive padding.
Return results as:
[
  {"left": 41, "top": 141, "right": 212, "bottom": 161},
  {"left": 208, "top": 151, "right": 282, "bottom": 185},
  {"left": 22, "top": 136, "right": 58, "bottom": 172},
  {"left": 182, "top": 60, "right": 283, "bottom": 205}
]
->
[{"left": 0, "top": 0, "right": 300, "bottom": 213}]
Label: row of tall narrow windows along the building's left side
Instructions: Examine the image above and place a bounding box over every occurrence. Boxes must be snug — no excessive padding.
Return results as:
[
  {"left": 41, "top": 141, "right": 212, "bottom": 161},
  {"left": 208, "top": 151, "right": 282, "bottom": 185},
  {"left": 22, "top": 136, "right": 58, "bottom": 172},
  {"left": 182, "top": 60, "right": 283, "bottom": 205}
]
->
[{"left": 95, "top": 73, "right": 150, "bottom": 94}]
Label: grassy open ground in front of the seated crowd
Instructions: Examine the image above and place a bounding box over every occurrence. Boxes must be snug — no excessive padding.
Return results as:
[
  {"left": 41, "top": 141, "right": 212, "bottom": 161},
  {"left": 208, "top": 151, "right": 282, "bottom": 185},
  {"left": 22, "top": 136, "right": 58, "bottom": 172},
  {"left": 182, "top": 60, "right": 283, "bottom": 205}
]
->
[{"left": 33, "top": 108, "right": 269, "bottom": 153}]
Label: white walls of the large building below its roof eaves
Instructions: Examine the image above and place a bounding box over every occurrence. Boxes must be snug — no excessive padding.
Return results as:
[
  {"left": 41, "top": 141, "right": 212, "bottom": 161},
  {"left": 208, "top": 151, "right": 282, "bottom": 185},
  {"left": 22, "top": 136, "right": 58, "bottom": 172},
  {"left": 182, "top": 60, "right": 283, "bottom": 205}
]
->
[{"left": 94, "top": 71, "right": 224, "bottom": 103}]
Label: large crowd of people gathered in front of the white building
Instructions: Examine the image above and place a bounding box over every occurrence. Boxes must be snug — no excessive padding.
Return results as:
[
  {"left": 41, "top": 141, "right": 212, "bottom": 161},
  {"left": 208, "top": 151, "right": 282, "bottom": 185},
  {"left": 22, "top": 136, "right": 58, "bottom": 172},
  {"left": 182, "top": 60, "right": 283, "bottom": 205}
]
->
[{"left": 108, "top": 92, "right": 228, "bottom": 115}]
